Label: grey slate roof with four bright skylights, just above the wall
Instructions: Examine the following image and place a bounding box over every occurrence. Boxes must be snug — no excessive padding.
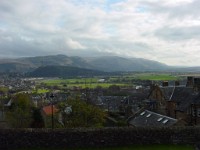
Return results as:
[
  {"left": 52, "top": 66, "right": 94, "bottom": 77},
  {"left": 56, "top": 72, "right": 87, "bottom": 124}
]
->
[{"left": 128, "top": 110, "right": 177, "bottom": 127}]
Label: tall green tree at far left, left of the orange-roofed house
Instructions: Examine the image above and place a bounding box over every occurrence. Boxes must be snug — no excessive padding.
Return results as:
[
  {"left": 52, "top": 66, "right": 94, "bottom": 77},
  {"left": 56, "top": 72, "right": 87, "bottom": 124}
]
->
[{"left": 6, "top": 94, "right": 32, "bottom": 128}]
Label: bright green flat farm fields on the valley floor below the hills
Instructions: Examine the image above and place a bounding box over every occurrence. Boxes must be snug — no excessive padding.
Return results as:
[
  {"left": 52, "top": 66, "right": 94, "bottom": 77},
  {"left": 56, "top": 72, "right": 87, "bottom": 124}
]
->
[{"left": 38, "top": 73, "right": 181, "bottom": 88}]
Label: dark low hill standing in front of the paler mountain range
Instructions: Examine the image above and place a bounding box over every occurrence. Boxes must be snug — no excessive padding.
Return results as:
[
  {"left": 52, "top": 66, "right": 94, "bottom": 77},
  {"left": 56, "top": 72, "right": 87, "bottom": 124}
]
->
[{"left": 27, "top": 66, "right": 107, "bottom": 77}]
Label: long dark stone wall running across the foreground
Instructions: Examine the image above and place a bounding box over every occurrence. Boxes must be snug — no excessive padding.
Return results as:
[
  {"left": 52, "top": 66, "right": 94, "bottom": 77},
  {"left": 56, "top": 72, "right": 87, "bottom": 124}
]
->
[{"left": 0, "top": 127, "right": 200, "bottom": 149}]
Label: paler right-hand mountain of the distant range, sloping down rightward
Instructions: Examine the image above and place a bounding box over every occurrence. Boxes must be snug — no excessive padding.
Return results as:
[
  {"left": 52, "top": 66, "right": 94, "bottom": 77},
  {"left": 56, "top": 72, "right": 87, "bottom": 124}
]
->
[{"left": 88, "top": 56, "right": 170, "bottom": 71}]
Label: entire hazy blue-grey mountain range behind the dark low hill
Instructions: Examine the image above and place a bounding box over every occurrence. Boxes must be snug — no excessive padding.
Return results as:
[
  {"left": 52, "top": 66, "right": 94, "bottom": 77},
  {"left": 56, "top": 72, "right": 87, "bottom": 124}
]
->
[{"left": 0, "top": 55, "right": 171, "bottom": 72}]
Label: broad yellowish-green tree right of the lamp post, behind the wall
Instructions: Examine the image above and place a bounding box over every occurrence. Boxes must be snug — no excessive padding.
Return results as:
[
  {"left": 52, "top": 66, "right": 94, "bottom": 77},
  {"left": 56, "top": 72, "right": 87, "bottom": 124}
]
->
[{"left": 59, "top": 99, "right": 105, "bottom": 127}]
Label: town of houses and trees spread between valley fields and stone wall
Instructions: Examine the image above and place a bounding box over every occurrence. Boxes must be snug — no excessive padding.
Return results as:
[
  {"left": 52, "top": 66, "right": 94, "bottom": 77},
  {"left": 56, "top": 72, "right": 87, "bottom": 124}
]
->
[{"left": 0, "top": 73, "right": 200, "bottom": 128}]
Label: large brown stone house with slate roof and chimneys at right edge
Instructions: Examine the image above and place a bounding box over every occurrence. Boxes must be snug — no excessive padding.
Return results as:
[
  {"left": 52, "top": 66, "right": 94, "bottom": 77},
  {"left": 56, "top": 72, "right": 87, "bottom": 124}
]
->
[{"left": 149, "top": 77, "right": 200, "bottom": 125}]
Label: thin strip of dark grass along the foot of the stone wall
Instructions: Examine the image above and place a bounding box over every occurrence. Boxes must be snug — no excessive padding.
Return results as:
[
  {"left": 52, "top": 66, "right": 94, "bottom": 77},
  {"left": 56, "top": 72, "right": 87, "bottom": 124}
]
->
[{"left": 19, "top": 145, "right": 194, "bottom": 150}]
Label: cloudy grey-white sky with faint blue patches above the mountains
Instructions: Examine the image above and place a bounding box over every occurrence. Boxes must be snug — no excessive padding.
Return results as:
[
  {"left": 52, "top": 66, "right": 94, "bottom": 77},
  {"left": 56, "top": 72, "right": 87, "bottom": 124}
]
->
[{"left": 0, "top": 0, "right": 200, "bottom": 66}]
